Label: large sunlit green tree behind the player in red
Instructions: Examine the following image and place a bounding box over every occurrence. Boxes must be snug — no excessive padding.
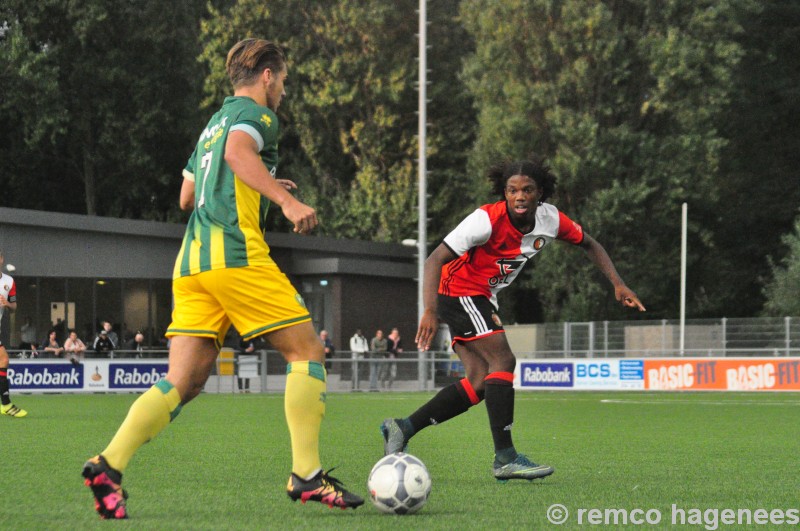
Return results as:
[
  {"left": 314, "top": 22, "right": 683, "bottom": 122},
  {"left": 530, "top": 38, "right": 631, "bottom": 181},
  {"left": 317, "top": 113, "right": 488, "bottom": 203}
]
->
[{"left": 461, "top": 0, "right": 750, "bottom": 320}]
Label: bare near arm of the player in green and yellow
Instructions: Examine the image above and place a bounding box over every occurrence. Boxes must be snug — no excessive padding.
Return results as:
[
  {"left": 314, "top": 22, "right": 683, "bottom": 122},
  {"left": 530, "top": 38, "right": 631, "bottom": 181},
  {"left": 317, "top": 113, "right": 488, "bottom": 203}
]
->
[{"left": 225, "top": 131, "right": 318, "bottom": 234}]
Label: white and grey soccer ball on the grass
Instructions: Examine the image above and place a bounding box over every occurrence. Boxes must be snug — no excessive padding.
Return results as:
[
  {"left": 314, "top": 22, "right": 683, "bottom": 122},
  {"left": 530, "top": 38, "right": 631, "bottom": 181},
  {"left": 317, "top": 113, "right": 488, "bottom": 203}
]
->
[{"left": 367, "top": 452, "right": 431, "bottom": 514}]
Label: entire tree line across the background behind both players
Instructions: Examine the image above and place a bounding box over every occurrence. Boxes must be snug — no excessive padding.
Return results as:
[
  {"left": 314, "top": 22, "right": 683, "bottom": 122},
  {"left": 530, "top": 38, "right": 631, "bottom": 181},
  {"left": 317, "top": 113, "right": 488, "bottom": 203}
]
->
[{"left": 0, "top": 0, "right": 800, "bottom": 322}]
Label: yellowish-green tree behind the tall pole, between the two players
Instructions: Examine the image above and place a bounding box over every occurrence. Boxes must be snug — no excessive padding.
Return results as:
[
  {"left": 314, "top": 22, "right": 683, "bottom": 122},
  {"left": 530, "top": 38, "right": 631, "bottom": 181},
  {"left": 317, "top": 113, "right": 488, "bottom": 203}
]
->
[{"left": 201, "top": 0, "right": 473, "bottom": 242}]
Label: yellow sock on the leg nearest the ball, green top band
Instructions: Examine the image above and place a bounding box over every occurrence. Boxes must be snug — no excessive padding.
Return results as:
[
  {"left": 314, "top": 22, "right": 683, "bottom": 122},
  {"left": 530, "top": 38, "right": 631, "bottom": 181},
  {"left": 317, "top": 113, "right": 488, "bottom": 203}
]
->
[{"left": 284, "top": 361, "right": 327, "bottom": 478}]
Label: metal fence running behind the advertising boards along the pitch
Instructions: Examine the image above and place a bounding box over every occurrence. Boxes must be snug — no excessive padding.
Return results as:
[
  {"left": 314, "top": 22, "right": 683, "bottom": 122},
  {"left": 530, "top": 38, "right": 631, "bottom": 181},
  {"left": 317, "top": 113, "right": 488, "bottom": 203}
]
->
[{"left": 8, "top": 317, "right": 800, "bottom": 393}]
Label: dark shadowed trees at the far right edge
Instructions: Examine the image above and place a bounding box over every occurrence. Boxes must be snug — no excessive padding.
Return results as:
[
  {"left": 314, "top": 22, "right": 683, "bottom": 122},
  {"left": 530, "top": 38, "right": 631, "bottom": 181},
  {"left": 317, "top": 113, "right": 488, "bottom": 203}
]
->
[{"left": 708, "top": 0, "right": 800, "bottom": 317}]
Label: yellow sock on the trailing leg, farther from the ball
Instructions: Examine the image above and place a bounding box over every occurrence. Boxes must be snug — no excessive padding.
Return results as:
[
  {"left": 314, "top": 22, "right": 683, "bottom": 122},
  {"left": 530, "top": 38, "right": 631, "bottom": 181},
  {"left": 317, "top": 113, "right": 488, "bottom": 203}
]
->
[{"left": 102, "top": 379, "right": 181, "bottom": 472}]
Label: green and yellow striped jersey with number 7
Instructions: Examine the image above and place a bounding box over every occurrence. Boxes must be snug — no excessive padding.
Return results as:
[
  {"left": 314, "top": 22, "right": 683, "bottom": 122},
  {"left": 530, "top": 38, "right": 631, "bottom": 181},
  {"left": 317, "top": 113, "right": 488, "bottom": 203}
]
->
[{"left": 173, "top": 96, "right": 278, "bottom": 278}]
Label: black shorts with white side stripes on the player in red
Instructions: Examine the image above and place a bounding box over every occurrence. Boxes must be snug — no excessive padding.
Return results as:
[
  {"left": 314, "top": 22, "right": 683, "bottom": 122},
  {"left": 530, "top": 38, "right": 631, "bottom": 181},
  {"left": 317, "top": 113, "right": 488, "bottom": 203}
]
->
[{"left": 437, "top": 294, "right": 504, "bottom": 343}]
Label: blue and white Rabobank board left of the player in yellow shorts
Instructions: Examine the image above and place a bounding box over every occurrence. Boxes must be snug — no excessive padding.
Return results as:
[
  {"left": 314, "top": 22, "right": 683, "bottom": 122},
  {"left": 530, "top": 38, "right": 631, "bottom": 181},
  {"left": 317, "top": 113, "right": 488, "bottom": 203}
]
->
[{"left": 8, "top": 359, "right": 168, "bottom": 393}]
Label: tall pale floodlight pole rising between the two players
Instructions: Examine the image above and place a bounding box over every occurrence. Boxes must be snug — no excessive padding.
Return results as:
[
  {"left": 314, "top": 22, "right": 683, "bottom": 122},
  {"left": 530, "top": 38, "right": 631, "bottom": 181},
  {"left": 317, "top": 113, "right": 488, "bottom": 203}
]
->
[{"left": 417, "top": 0, "right": 428, "bottom": 389}]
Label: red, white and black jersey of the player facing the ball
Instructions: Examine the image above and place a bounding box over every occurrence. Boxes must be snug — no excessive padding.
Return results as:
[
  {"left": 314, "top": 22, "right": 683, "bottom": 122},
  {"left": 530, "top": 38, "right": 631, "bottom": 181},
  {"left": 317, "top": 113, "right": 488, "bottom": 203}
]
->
[{"left": 439, "top": 201, "right": 583, "bottom": 308}]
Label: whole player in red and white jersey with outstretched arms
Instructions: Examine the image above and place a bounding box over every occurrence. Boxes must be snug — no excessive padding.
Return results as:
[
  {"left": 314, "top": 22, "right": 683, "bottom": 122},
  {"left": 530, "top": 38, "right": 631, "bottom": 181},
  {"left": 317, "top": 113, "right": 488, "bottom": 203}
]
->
[{"left": 381, "top": 159, "right": 645, "bottom": 481}]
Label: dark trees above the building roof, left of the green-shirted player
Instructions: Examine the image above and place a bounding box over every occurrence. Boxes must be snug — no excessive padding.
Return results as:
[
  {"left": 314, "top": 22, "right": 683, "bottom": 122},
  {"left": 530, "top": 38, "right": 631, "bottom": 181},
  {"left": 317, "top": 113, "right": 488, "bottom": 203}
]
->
[{"left": 0, "top": 0, "right": 202, "bottom": 219}]
